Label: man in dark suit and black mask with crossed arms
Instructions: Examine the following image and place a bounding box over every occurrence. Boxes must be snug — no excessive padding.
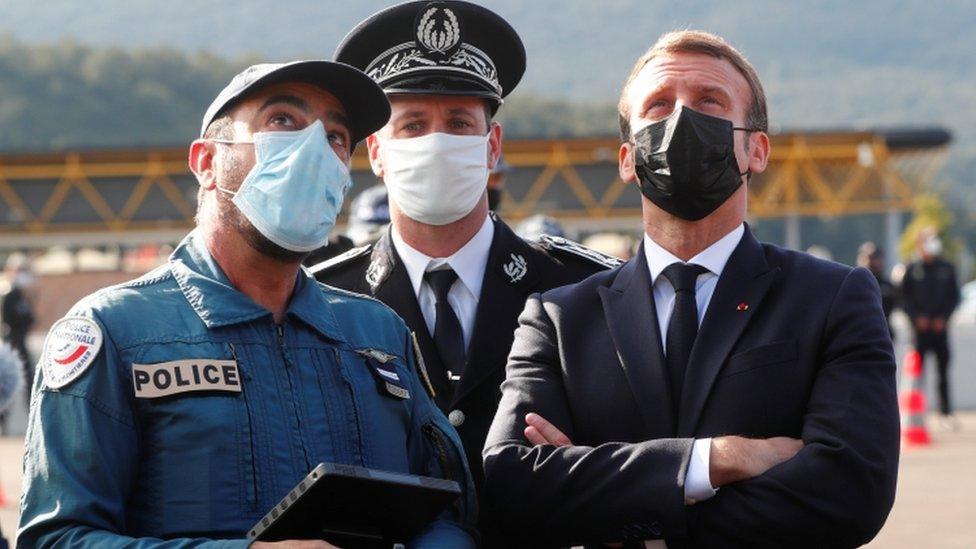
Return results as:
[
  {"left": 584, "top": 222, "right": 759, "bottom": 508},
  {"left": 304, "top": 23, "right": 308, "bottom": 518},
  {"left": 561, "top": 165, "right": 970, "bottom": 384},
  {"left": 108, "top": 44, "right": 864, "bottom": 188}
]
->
[{"left": 484, "top": 31, "right": 899, "bottom": 549}]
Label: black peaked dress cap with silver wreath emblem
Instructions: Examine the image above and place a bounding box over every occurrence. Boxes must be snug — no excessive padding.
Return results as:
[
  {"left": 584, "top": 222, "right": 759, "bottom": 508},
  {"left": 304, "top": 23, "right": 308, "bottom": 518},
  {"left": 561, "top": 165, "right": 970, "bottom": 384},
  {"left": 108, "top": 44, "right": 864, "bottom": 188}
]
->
[{"left": 335, "top": 0, "right": 525, "bottom": 111}]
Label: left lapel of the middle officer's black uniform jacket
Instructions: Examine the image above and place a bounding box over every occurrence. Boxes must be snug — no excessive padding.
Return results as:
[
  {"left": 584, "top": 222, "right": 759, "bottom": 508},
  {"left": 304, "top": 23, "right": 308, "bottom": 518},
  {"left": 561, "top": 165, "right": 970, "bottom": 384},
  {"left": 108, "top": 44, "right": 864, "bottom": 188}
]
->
[{"left": 367, "top": 229, "right": 451, "bottom": 404}]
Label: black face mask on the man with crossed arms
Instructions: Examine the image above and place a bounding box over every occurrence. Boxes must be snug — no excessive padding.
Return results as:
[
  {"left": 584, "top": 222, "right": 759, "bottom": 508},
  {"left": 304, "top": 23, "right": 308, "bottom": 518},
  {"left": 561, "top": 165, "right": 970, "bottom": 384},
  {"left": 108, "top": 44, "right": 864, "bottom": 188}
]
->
[{"left": 634, "top": 107, "right": 751, "bottom": 221}]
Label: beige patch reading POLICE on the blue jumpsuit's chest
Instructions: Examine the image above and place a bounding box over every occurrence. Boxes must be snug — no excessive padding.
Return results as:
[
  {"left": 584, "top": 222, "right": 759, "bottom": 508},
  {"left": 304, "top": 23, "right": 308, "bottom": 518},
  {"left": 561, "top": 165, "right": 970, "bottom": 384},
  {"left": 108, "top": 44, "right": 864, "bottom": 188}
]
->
[{"left": 132, "top": 358, "right": 241, "bottom": 398}]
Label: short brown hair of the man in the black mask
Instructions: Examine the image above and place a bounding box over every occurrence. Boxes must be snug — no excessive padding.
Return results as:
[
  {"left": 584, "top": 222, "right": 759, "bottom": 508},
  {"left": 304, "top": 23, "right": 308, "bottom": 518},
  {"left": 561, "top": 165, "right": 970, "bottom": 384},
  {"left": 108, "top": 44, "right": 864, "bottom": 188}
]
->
[{"left": 617, "top": 30, "right": 769, "bottom": 141}]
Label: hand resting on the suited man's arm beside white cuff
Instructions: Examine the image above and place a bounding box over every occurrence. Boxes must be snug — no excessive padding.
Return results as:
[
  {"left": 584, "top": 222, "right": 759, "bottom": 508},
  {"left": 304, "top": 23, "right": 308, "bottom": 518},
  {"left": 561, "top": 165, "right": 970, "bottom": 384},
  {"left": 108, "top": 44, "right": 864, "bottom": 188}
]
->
[{"left": 708, "top": 436, "right": 803, "bottom": 488}]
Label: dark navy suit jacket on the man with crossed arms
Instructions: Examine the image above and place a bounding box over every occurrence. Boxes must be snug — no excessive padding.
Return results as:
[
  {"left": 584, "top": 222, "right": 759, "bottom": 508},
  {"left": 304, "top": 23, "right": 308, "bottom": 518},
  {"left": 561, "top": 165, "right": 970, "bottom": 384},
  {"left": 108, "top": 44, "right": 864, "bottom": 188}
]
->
[{"left": 484, "top": 225, "right": 899, "bottom": 549}]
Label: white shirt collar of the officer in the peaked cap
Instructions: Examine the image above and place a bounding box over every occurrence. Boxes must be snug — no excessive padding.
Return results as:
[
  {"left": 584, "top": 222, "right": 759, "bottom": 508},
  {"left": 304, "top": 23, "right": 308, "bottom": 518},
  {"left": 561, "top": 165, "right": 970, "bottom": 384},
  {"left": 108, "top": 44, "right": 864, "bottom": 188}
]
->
[{"left": 390, "top": 216, "right": 495, "bottom": 297}]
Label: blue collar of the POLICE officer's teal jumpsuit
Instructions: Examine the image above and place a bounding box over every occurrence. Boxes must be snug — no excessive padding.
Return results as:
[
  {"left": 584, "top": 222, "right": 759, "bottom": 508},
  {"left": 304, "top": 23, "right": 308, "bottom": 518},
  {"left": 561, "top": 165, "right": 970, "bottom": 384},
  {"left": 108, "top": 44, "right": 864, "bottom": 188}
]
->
[{"left": 169, "top": 229, "right": 343, "bottom": 340}]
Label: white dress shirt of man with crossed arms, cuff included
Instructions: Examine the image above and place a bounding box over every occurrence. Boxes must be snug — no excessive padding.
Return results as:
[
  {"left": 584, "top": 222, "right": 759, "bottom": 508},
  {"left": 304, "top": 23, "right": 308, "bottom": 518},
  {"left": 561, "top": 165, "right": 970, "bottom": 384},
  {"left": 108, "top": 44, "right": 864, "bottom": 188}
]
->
[{"left": 644, "top": 225, "right": 745, "bottom": 503}]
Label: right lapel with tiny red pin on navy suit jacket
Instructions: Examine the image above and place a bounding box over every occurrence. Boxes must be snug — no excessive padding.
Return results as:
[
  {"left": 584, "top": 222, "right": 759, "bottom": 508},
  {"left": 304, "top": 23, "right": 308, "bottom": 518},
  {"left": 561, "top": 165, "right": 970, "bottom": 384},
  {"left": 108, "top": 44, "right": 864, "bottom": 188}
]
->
[{"left": 677, "top": 227, "right": 779, "bottom": 437}]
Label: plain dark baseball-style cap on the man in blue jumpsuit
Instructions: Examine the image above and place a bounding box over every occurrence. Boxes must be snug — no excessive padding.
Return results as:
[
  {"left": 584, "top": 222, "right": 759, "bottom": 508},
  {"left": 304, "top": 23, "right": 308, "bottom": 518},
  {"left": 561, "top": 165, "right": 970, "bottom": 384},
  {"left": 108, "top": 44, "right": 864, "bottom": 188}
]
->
[{"left": 200, "top": 60, "right": 390, "bottom": 143}]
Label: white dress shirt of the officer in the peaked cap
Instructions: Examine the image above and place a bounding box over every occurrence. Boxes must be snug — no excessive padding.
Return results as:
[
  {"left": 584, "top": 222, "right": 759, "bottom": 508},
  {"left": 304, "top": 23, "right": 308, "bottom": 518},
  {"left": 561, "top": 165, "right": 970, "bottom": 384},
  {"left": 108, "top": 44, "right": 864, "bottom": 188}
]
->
[{"left": 391, "top": 212, "right": 495, "bottom": 349}]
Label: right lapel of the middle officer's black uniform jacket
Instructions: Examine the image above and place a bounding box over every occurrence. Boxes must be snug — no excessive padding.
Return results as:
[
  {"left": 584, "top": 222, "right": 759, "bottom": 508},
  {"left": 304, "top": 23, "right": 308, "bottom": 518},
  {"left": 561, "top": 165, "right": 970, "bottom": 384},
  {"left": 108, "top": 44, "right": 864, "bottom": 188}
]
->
[{"left": 453, "top": 215, "right": 542, "bottom": 404}]
